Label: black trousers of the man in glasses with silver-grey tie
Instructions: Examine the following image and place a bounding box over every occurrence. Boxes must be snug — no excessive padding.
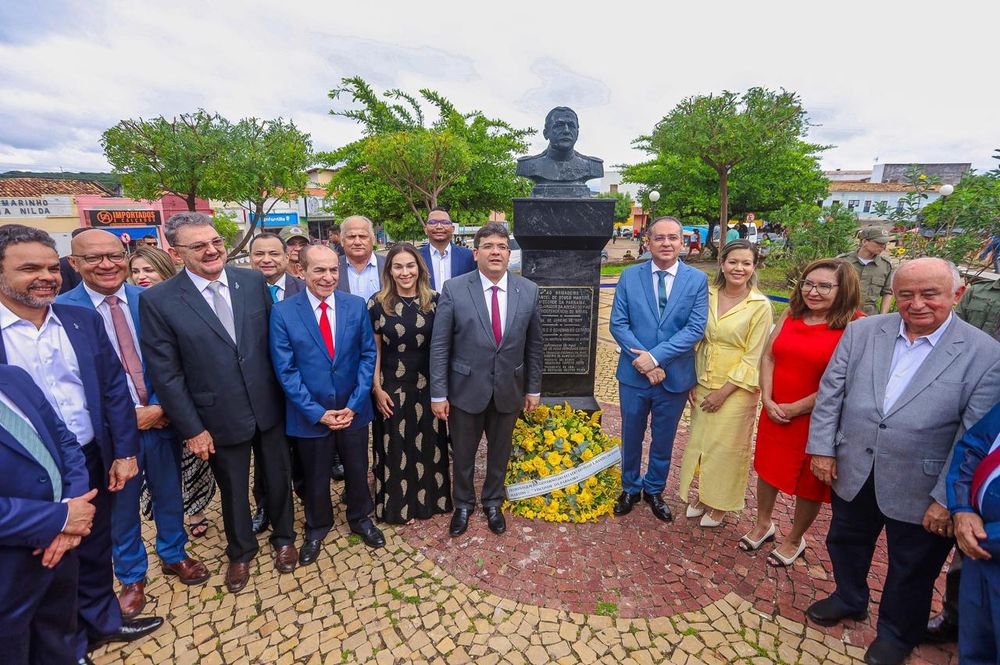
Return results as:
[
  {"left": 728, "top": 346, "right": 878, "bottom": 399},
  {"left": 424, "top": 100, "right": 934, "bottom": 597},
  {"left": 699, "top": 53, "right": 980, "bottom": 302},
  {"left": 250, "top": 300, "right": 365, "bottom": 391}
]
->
[{"left": 208, "top": 424, "right": 295, "bottom": 563}]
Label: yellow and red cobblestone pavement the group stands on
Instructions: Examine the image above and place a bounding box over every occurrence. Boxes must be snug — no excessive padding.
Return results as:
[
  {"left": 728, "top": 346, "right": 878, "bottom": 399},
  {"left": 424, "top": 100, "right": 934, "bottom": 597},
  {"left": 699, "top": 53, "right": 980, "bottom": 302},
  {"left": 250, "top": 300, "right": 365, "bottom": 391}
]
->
[{"left": 94, "top": 282, "right": 957, "bottom": 665}]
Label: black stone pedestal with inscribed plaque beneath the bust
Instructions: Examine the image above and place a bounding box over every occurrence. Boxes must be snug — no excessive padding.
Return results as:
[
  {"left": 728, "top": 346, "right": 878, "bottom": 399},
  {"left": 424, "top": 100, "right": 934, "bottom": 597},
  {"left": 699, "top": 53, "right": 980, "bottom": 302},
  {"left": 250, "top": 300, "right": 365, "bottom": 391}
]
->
[{"left": 514, "top": 197, "right": 615, "bottom": 412}]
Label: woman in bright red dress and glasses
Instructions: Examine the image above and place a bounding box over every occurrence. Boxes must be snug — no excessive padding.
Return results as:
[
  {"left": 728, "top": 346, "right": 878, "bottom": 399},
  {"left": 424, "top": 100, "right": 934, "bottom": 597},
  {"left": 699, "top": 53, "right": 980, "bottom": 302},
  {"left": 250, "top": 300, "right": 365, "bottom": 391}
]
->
[{"left": 739, "top": 259, "right": 862, "bottom": 566}]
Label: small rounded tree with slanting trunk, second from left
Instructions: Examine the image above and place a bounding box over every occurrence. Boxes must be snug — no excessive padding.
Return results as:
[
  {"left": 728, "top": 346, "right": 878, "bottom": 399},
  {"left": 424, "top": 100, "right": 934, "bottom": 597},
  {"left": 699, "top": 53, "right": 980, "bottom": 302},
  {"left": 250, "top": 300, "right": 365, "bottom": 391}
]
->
[{"left": 210, "top": 118, "right": 313, "bottom": 256}]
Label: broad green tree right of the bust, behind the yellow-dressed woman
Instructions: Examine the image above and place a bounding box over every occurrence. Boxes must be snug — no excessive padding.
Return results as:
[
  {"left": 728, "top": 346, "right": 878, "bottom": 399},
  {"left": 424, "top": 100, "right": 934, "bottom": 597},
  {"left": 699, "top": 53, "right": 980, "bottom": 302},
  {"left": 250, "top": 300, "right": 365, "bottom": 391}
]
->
[{"left": 624, "top": 88, "right": 826, "bottom": 251}]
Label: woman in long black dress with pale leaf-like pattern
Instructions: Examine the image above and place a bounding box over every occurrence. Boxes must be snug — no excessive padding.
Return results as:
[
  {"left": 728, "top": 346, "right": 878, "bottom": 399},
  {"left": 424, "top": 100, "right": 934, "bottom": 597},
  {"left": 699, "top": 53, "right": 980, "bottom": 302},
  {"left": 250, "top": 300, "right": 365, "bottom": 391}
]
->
[{"left": 368, "top": 242, "right": 452, "bottom": 524}]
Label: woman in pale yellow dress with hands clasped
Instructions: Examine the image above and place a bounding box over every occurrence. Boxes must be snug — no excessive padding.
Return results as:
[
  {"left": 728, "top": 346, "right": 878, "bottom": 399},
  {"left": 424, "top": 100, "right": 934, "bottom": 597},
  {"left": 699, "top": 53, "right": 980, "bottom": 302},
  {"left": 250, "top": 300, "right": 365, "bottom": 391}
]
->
[{"left": 680, "top": 240, "right": 773, "bottom": 528}]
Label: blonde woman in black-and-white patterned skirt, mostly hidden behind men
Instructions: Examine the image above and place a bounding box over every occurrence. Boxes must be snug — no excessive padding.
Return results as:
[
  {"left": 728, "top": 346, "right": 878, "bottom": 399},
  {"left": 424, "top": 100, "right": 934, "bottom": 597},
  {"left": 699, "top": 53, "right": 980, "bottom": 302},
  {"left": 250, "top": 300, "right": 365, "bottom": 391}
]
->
[{"left": 128, "top": 245, "right": 215, "bottom": 538}]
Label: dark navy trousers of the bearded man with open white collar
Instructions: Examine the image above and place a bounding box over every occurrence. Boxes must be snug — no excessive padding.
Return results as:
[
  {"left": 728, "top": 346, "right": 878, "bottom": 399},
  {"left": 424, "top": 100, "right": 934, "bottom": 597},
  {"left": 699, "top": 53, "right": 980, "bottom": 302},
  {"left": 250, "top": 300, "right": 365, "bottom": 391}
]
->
[{"left": 76, "top": 442, "right": 122, "bottom": 658}]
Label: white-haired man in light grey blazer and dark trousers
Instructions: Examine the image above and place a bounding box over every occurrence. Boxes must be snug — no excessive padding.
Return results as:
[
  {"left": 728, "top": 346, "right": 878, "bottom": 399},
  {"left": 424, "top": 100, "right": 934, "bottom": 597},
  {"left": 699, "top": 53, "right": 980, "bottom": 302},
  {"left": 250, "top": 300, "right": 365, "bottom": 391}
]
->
[{"left": 806, "top": 258, "right": 1000, "bottom": 665}]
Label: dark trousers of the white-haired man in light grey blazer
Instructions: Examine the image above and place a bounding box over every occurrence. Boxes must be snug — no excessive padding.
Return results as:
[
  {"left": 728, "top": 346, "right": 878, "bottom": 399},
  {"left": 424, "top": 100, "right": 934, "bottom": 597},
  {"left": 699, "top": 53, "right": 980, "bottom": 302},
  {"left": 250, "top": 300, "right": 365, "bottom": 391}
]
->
[{"left": 826, "top": 471, "right": 954, "bottom": 648}]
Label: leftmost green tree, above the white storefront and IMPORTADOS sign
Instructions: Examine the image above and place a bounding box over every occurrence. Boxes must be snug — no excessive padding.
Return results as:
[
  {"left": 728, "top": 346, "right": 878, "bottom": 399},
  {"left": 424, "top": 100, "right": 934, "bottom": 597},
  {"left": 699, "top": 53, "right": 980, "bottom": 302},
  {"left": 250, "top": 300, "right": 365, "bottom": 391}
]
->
[{"left": 101, "top": 109, "right": 229, "bottom": 210}]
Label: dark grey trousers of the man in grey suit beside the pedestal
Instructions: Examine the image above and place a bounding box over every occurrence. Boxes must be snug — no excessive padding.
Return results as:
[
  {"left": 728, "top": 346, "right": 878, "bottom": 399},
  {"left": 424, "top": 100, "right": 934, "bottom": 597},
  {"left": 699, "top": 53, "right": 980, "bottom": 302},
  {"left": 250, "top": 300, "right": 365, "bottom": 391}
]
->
[{"left": 448, "top": 399, "right": 520, "bottom": 509}]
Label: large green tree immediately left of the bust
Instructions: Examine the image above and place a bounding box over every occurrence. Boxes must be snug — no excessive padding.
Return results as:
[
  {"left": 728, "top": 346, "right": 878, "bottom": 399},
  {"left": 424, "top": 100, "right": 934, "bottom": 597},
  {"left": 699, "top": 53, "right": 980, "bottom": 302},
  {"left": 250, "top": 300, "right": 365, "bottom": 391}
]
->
[{"left": 320, "top": 76, "right": 534, "bottom": 238}]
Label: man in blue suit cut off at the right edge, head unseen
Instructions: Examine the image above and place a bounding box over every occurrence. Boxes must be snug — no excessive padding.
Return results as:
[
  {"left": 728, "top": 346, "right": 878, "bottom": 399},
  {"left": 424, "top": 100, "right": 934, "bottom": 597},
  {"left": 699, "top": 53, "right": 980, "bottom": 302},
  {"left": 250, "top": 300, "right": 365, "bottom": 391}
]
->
[{"left": 947, "top": 402, "right": 1000, "bottom": 665}]
